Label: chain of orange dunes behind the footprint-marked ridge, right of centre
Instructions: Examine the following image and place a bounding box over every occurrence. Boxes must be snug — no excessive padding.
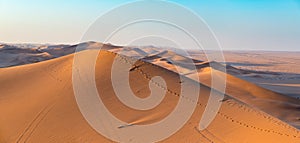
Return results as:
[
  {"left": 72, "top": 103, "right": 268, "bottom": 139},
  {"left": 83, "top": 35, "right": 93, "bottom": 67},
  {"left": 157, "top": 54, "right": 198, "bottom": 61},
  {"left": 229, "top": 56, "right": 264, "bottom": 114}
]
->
[{"left": 113, "top": 47, "right": 300, "bottom": 128}]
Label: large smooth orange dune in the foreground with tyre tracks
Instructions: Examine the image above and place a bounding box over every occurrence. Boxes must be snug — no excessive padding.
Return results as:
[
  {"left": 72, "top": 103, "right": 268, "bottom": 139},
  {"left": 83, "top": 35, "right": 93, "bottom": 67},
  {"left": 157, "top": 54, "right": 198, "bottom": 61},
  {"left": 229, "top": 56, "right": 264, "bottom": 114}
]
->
[{"left": 0, "top": 50, "right": 300, "bottom": 143}]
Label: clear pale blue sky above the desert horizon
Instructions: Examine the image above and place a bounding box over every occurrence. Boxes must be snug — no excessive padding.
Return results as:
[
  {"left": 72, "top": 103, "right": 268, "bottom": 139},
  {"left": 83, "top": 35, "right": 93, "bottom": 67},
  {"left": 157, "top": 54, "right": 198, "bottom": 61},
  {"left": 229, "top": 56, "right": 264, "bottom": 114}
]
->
[{"left": 0, "top": 0, "right": 300, "bottom": 51}]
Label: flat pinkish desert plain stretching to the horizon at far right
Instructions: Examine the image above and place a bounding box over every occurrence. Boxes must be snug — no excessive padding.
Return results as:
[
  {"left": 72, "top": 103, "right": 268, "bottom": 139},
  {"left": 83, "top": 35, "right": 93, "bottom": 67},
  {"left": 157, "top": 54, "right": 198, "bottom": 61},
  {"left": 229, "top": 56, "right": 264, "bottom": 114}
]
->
[{"left": 189, "top": 50, "right": 300, "bottom": 99}]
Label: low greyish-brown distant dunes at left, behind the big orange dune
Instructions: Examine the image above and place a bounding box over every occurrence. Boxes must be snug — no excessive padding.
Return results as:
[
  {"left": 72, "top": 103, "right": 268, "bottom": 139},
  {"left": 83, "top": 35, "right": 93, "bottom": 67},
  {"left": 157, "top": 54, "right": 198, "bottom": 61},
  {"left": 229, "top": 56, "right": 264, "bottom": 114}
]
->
[{"left": 0, "top": 42, "right": 122, "bottom": 68}]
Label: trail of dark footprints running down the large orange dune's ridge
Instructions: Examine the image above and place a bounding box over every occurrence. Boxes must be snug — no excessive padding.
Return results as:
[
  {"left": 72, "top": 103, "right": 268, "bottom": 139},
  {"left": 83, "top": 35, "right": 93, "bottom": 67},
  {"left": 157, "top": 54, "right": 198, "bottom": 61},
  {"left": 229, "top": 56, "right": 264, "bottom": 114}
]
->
[{"left": 106, "top": 51, "right": 300, "bottom": 138}]
